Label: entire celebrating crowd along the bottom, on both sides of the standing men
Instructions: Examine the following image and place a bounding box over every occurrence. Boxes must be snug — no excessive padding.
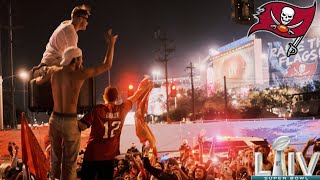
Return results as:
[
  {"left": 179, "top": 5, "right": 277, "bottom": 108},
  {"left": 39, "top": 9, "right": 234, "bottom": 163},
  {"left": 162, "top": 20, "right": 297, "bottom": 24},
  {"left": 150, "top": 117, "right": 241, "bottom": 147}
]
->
[{"left": 0, "top": 128, "right": 320, "bottom": 180}]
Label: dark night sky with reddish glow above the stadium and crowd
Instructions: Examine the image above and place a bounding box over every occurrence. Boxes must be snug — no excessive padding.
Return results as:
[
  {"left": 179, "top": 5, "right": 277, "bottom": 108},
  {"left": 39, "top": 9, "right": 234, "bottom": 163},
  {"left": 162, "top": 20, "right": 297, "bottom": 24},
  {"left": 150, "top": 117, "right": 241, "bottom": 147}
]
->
[{"left": 0, "top": 0, "right": 312, "bottom": 103}]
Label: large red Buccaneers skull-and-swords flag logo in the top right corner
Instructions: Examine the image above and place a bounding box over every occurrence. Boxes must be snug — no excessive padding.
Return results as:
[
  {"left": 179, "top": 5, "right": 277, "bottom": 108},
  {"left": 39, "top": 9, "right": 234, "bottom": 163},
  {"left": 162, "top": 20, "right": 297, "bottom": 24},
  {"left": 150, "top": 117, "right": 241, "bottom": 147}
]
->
[{"left": 248, "top": 0, "right": 317, "bottom": 57}]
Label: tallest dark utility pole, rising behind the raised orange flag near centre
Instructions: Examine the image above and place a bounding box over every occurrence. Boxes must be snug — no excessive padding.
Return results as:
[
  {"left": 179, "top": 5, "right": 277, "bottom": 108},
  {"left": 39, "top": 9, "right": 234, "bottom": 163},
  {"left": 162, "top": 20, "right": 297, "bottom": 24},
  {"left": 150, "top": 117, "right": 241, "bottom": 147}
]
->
[{"left": 154, "top": 29, "right": 175, "bottom": 120}]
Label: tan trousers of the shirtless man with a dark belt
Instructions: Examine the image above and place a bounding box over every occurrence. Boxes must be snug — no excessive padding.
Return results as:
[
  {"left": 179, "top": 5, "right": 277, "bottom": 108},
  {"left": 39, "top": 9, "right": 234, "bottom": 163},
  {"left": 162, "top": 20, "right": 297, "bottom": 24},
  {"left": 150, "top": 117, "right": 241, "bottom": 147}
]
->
[{"left": 49, "top": 114, "right": 81, "bottom": 180}]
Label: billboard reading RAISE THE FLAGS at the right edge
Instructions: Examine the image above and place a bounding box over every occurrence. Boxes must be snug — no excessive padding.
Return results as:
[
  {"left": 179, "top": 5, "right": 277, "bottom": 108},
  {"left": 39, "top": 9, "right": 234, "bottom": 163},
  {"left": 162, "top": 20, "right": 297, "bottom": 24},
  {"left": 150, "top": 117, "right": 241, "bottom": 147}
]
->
[{"left": 267, "top": 37, "right": 320, "bottom": 86}]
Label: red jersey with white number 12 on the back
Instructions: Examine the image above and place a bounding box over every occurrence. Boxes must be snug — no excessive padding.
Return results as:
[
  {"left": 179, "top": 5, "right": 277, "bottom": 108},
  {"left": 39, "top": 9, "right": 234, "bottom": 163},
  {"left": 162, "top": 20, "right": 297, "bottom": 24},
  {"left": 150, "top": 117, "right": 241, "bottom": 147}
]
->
[{"left": 80, "top": 100, "right": 132, "bottom": 161}]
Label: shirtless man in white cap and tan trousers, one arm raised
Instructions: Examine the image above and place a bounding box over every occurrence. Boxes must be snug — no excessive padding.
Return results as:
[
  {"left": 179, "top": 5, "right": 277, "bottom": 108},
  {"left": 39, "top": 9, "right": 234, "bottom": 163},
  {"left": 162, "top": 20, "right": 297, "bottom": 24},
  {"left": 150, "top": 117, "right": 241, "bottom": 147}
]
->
[{"left": 37, "top": 29, "right": 117, "bottom": 180}]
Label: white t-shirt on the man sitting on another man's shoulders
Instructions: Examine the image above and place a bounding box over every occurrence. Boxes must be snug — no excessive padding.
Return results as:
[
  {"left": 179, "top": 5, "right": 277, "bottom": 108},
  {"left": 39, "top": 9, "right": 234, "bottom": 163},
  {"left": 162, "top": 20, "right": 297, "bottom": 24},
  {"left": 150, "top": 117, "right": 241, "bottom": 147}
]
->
[{"left": 41, "top": 20, "right": 78, "bottom": 66}]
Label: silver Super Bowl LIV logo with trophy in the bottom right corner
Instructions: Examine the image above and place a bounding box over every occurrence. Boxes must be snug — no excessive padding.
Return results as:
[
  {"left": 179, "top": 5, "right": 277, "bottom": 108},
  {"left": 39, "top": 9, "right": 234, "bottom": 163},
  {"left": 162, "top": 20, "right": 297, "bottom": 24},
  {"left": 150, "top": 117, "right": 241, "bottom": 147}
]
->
[{"left": 252, "top": 136, "right": 320, "bottom": 180}]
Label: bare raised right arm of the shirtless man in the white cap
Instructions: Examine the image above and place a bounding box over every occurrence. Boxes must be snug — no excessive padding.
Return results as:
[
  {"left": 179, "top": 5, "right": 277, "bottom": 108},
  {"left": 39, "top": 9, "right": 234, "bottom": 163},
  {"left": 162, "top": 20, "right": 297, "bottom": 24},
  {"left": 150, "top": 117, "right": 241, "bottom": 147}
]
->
[{"left": 79, "top": 29, "right": 118, "bottom": 79}]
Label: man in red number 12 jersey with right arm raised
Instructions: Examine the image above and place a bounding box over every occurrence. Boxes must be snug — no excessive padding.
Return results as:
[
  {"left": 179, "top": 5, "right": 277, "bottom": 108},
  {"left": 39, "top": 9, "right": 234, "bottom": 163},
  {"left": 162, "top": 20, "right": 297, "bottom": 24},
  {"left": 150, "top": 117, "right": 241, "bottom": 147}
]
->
[{"left": 78, "top": 77, "right": 153, "bottom": 180}]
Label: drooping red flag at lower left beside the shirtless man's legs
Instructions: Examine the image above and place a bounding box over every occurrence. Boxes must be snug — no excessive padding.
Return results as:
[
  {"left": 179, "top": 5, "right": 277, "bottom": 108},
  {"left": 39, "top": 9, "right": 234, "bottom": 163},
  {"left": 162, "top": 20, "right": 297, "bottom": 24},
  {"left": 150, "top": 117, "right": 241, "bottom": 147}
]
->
[{"left": 21, "top": 113, "right": 50, "bottom": 179}]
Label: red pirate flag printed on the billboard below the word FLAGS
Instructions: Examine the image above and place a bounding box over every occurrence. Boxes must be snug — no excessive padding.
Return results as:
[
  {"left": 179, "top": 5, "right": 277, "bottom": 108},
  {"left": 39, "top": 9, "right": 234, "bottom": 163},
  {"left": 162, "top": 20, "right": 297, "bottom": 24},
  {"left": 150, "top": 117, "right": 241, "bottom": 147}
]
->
[{"left": 286, "top": 62, "right": 317, "bottom": 81}]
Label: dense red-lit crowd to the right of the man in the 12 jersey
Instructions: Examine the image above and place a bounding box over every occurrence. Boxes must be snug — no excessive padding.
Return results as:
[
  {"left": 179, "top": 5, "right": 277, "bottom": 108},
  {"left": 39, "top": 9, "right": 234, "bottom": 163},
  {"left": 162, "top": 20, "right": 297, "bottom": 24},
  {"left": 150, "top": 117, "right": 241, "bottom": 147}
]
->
[{"left": 71, "top": 138, "right": 320, "bottom": 180}]
